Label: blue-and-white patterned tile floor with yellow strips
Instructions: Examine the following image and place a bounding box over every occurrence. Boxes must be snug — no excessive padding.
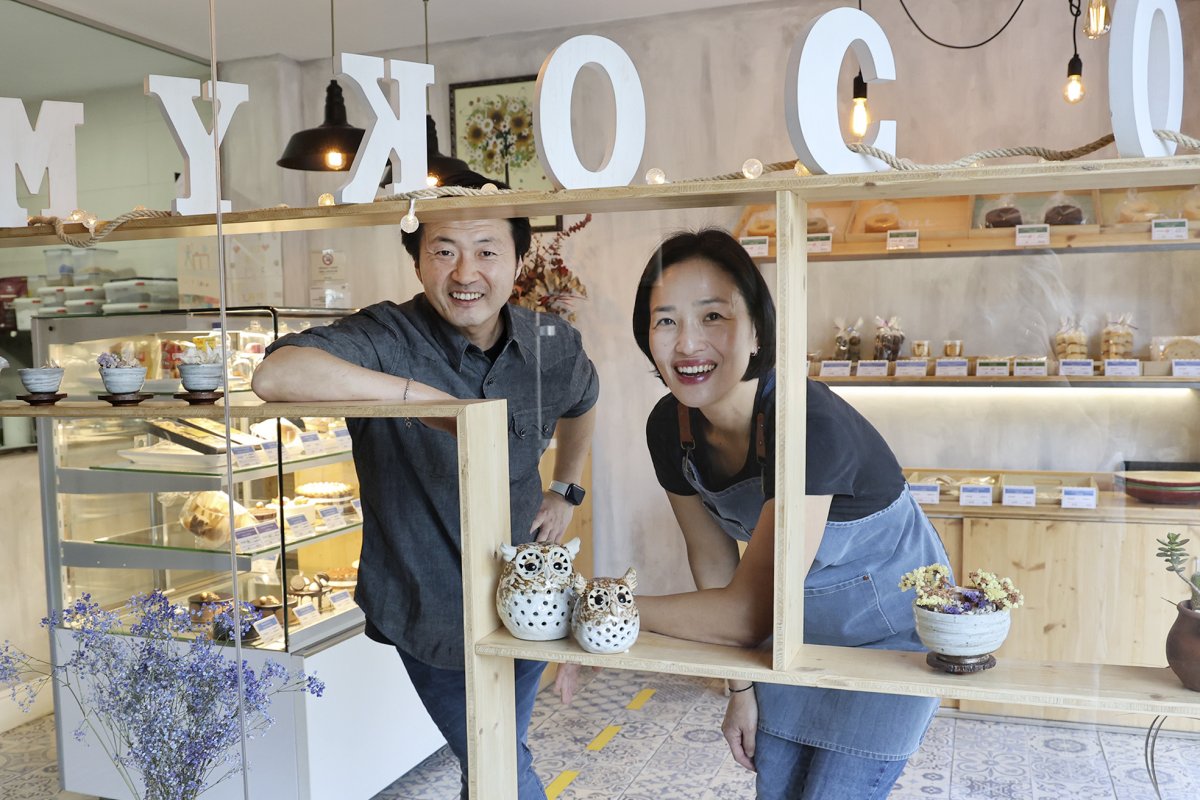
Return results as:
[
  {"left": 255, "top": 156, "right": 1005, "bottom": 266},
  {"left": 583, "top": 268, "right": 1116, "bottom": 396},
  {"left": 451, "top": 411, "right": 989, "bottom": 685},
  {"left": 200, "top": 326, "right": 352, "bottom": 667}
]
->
[{"left": 7, "top": 669, "right": 1200, "bottom": 800}]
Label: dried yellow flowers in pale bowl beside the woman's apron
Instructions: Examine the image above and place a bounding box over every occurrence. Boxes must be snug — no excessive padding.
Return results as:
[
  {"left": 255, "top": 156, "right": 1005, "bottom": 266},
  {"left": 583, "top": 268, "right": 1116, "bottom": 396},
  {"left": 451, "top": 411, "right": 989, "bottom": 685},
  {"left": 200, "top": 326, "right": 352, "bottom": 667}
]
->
[{"left": 900, "top": 564, "right": 1025, "bottom": 673}]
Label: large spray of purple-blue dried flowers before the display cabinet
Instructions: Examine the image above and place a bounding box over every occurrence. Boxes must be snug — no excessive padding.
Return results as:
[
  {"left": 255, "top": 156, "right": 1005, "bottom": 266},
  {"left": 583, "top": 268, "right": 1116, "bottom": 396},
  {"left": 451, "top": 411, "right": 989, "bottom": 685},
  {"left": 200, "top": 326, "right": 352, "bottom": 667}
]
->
[{"left": 0, "top": 591, "right": 325, "bottom": 800}]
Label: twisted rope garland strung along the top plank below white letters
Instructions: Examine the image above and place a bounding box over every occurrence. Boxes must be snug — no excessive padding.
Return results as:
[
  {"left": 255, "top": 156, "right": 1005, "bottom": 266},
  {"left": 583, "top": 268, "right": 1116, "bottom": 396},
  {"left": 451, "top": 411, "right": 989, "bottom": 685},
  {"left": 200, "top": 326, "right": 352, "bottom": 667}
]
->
[{"left": 29, "top": 131, "right": 1200, "bottom": 248}]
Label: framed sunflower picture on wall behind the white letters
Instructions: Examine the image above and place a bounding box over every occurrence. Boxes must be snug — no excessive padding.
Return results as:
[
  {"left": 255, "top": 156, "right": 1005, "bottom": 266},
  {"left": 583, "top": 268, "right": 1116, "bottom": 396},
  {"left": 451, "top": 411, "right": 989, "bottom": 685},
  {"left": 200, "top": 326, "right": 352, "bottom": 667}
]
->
[{"left": 450, "top": 76, "right": 563, "bottom": 231}]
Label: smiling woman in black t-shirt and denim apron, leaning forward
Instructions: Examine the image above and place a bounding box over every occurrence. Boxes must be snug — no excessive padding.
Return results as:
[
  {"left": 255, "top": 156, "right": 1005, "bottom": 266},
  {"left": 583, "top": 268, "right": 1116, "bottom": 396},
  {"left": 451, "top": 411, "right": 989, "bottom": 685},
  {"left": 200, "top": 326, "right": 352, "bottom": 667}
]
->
[{"left": 634, "top": 229, "right": 947, "bottom": 799}]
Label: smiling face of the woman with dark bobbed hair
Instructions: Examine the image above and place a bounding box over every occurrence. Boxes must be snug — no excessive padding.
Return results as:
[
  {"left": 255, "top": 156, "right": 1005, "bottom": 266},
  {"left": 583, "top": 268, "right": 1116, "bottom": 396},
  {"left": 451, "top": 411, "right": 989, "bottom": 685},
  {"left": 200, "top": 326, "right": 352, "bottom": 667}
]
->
[{"left": 649, "top": 257, "right": 757, "bottom": 408}]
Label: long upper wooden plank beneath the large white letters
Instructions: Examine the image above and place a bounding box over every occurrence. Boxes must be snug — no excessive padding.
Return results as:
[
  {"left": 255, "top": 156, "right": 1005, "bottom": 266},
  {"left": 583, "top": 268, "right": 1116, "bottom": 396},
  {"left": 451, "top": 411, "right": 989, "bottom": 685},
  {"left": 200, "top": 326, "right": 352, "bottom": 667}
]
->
[{"left": 0, "top": 156, "right": 1200, "bottom": 248}]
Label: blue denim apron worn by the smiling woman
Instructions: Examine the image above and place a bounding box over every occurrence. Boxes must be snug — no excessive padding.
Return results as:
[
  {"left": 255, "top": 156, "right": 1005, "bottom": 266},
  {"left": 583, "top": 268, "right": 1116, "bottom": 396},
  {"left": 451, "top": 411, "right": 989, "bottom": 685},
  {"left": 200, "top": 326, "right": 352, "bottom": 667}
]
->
[{"left": 684, "top": 419, "right": 949, "bottom": 760}]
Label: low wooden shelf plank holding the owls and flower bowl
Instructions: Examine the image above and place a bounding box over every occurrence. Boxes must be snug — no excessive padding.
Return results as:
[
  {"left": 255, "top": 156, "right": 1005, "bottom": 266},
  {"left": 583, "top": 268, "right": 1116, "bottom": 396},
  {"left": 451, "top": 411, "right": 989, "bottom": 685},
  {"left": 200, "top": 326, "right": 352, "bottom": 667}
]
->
[{"left": 475, "top": 633, "right": 1200, "bottom": 716}]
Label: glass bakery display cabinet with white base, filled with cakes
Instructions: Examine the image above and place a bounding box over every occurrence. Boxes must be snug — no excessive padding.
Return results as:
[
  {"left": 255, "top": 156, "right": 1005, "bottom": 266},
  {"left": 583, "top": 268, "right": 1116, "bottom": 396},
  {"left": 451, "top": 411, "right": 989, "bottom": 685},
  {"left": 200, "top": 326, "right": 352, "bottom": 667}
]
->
[{"left": 22, "top": 308, "right": 442, "bottom": 799}]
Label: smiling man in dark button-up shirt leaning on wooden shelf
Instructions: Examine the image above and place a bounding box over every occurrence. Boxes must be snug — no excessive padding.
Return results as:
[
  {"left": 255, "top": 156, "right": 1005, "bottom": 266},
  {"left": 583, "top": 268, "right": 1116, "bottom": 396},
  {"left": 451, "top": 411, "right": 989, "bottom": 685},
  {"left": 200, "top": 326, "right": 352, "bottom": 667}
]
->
[{"left": 253, "top": 209, "right": 599, "bottom": 800}]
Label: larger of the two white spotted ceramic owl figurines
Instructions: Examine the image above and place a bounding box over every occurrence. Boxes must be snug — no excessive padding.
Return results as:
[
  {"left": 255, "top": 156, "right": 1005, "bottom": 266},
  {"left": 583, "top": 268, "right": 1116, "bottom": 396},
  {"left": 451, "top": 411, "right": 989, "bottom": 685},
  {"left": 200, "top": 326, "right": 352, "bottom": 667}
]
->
[{"left": 496, "top": 539, "right": 580, "bottom": 642}]
